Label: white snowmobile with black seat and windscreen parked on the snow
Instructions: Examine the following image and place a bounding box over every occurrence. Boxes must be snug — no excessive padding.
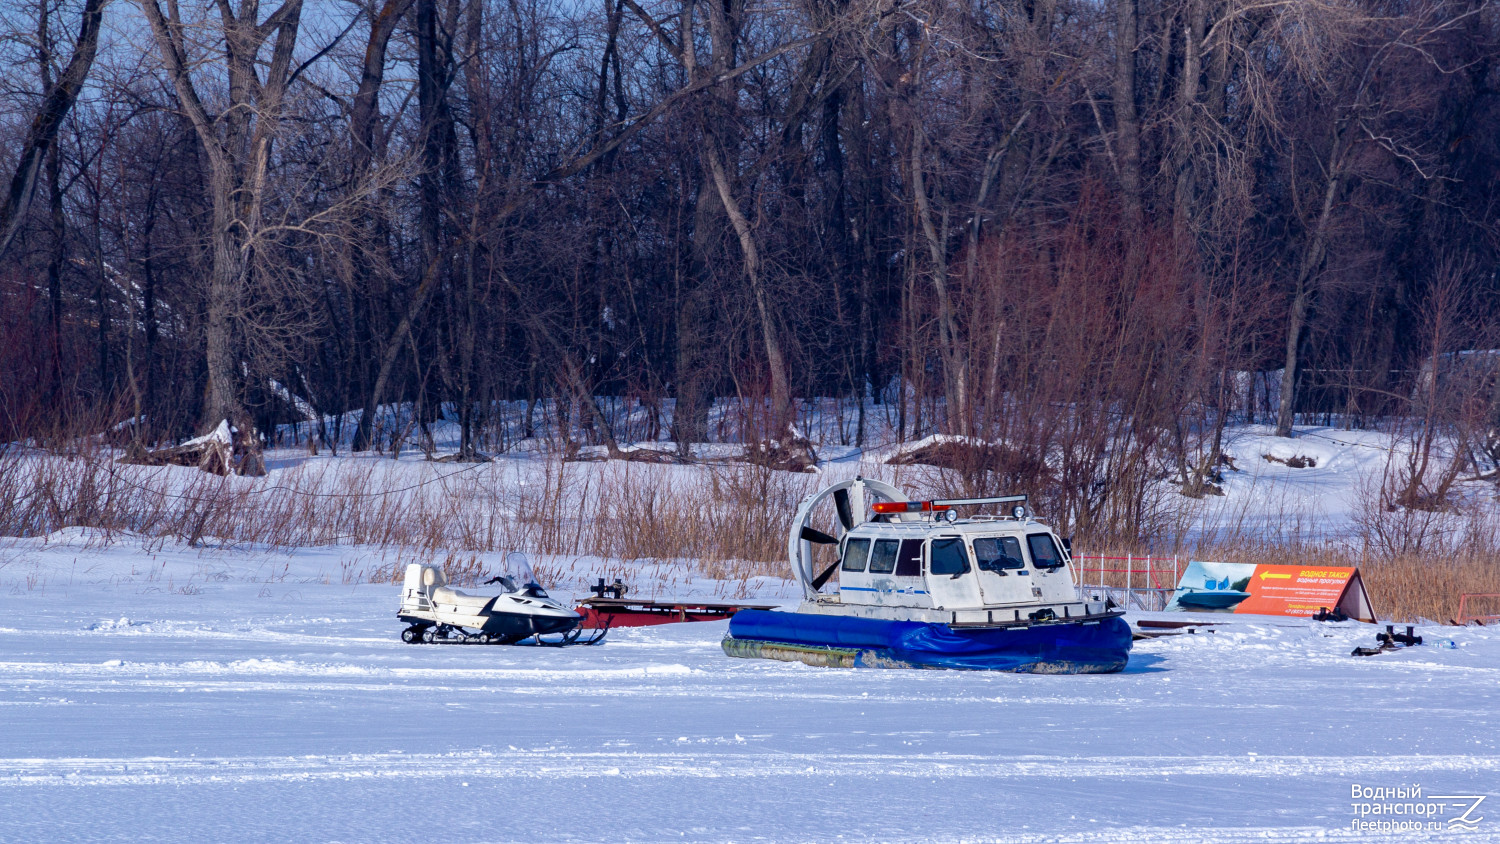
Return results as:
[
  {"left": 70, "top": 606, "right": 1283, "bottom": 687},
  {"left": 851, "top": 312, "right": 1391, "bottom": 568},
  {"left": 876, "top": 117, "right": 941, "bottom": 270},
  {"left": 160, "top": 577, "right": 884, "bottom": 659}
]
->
[{"left": 396, "top": 553, "right": 605, "bottom": 645}]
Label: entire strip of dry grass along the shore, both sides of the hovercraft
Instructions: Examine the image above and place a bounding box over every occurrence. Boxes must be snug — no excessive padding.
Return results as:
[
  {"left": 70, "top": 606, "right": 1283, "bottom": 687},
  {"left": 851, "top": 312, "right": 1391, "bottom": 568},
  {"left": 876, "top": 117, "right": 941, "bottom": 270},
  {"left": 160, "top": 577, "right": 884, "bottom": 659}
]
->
[{"left": 0, "top": 448, "right": 1500, "bottom": 622}]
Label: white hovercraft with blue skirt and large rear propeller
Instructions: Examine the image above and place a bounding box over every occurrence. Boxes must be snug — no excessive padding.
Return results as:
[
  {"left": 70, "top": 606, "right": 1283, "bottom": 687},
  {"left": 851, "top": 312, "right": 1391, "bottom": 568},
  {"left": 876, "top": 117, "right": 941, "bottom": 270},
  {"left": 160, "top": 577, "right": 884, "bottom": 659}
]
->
[{"left": 723, "top": 478, "right": 1131, "bottom": 675}]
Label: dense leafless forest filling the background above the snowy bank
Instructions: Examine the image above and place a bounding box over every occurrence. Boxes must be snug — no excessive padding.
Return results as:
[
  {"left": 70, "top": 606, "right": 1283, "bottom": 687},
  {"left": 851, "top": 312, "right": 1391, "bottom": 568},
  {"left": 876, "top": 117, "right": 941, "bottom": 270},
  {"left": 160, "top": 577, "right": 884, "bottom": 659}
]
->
[{"left": 0, "top": 0, "right": 1500, "bottom": 509}]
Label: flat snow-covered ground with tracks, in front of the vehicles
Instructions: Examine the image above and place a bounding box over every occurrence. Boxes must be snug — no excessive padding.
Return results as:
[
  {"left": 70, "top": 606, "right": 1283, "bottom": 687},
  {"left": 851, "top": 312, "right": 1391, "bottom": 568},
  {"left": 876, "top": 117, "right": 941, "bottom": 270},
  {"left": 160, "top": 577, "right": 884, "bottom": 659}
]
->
[{"left": 0, "top": 542, "right": 1500, "bottom": 843}]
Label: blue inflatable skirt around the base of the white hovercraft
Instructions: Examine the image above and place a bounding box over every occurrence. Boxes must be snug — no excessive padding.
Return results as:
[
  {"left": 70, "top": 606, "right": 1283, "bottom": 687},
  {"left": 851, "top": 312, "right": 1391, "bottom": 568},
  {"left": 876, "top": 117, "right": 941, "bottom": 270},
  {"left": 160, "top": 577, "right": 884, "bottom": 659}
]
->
[{"left": 723, "top": 610, "right": 1131, "bottom": 675}]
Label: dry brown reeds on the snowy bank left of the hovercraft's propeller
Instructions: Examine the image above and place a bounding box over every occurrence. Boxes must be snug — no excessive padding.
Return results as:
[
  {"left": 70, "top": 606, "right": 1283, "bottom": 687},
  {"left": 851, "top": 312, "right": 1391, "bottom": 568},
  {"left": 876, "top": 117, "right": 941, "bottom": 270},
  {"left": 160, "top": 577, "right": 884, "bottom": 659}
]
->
[{"left": 0, "top": 448, "right": 816, "bottom": 582}]
